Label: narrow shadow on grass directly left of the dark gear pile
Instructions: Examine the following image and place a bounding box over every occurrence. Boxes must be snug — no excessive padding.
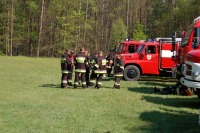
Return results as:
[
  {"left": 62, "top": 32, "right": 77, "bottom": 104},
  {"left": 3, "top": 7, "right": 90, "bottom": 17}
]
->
[{"left": 128, "top": 87, "right": 154, "bottom": 94}]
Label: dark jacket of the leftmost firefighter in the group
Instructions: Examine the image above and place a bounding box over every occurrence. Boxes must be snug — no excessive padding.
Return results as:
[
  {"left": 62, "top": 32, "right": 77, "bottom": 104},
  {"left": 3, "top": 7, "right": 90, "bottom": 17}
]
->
[{"left": 61, "top": 54, "right": 72, "bottom": 74}]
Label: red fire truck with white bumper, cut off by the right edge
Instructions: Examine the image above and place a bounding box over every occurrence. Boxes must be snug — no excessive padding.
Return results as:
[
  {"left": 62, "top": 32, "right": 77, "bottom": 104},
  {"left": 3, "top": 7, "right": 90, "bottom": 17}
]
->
[{"left": 173, "top": 17, "right": 200, "bottom": 98}]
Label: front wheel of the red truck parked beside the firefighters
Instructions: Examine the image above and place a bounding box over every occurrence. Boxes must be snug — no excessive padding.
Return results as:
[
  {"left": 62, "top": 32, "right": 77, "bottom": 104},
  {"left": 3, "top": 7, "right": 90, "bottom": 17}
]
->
[{"left": 124, "top": 65, "right": 140, "bottom": 81}]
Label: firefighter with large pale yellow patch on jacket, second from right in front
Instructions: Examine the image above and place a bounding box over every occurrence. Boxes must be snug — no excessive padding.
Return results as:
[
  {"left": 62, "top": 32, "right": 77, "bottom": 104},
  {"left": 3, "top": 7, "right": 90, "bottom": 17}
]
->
[{"left": 94, "top": 51, "right": 107, "bottom": 89}]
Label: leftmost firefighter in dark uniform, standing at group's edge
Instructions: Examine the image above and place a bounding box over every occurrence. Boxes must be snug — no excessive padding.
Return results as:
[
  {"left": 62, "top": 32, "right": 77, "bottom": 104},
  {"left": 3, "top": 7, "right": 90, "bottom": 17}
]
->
[{"left": 61, "top": 50, "right": 72, "bottom": 88}]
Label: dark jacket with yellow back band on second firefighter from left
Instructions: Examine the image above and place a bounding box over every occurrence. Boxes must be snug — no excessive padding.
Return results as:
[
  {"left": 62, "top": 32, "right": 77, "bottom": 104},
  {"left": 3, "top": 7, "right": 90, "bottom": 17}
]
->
[{"left": 74, "top": 52, "right": 87, "bottom": 73}]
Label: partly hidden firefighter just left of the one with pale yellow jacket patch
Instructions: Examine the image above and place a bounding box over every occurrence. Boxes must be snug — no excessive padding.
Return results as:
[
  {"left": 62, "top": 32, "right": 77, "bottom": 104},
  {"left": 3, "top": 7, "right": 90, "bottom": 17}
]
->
[{"left": 89, "top": 53, "right": 98, "bottom": 87}]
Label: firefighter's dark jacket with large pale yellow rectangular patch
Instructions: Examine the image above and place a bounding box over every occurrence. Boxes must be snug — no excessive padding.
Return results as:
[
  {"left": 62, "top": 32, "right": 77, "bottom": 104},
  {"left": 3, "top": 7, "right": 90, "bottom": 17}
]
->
[{"left": 94, "top": 56, "right": 107, "bottom": 74}]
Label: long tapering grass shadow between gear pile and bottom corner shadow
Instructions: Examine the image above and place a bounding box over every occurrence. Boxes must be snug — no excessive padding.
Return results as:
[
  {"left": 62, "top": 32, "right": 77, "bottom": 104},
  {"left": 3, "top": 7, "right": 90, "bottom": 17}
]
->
[{"left": 142, "top": 96, "right": 200, "bottom": 109}]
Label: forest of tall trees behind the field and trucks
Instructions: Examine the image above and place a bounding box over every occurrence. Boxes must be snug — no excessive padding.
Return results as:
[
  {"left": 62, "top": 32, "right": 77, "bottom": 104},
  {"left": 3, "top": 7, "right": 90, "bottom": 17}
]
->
[{"left": 0, "top": 0, "right": 200, "bottom": 57}]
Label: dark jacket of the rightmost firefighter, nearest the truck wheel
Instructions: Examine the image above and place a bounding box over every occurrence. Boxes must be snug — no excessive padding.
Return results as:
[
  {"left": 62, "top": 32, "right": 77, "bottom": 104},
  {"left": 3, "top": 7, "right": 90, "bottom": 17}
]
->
[{"left": 114, "top": 59, "right": 124, "bottom": 77}]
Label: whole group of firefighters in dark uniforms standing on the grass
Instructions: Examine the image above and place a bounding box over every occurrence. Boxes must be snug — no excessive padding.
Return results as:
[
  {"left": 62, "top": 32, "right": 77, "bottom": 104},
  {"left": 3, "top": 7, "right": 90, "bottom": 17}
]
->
[{"left": 61, "top": 48, "right": 124, "bottom": 89}]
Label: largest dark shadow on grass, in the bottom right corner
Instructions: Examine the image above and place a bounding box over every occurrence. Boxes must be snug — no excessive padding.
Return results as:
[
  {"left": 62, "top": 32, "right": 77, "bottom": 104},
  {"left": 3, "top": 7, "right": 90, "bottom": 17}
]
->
[{"left": 135, "top": 110, "right": 200, "bottom": 133}]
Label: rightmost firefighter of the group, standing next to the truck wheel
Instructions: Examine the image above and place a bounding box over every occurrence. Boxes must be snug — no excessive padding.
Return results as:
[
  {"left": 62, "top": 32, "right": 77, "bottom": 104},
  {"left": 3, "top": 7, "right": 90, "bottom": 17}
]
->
[{"left": 113, "top": 55, "right": 124, "bottom": 89}]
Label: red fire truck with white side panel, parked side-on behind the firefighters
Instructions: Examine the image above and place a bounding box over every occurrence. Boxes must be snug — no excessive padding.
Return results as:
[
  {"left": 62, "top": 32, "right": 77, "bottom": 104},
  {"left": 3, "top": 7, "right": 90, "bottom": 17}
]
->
[{"left": 116, "top": 38, "right": 180, "bottom": 81}]
